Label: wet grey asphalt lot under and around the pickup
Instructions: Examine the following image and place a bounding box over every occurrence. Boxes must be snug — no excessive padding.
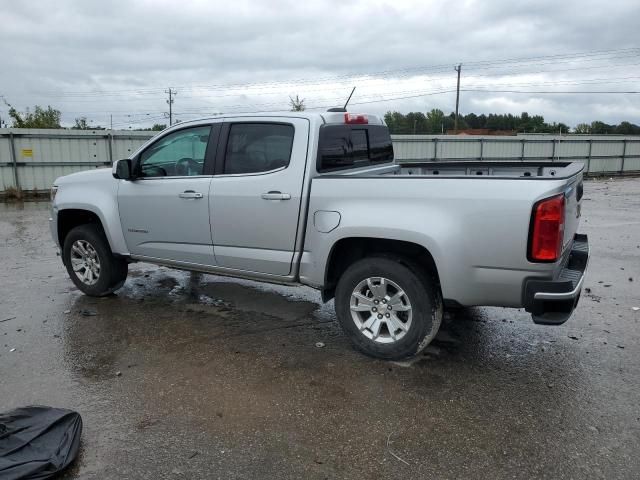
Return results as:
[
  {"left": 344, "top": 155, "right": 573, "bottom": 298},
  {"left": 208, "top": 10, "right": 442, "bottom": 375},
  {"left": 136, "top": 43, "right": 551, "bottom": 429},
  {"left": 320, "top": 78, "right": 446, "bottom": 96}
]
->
[{"left": 0, "top": 179, "right": 640, "bottom": 479}]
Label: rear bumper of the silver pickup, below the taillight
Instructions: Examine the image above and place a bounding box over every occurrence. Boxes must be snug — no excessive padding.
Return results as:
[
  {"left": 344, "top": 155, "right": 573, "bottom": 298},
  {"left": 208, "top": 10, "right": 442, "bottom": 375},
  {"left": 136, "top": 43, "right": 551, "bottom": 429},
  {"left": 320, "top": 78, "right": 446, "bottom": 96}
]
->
[{"left": 524, "top": 234, "right": 589, "bottom": 325}]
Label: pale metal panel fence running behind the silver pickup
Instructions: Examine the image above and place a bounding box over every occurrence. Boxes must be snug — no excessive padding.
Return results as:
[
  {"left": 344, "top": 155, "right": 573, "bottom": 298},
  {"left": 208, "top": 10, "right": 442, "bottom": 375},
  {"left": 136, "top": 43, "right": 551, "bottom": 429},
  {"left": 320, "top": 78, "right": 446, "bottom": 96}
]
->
[{"left": 0, "top": 129, "right": 640, "bottom": 193}]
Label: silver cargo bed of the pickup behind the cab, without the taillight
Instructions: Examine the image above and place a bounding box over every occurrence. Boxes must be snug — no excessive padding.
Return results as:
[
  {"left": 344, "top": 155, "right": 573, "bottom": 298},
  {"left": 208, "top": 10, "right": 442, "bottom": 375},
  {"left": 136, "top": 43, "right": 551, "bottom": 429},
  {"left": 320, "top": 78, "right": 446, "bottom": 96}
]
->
[{"left": 303, "top": 158, "right": 584, "bottom": 307}]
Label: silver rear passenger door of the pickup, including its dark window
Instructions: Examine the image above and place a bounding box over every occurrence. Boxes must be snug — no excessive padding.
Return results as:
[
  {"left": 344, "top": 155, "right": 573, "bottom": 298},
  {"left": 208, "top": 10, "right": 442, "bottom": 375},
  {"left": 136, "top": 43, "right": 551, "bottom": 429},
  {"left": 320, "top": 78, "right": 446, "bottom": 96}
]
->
[{"left": 210, "top": 117, "right": 309, "bottom": 276}]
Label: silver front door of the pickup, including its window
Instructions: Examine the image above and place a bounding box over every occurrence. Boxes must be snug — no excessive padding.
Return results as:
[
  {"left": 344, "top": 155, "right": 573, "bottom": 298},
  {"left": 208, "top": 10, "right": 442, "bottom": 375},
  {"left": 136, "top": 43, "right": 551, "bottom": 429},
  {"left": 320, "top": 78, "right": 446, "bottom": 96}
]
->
[{"left": 118, "top": 124, "right": 220, "bottom": 265}]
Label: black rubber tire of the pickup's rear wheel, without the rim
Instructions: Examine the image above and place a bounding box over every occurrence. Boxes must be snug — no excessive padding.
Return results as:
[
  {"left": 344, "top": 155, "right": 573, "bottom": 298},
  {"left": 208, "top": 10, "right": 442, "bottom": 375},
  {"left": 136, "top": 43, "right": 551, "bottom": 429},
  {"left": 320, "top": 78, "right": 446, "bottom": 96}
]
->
[{"left": 335, "top": 257, "right": 443, "bottom": 360}]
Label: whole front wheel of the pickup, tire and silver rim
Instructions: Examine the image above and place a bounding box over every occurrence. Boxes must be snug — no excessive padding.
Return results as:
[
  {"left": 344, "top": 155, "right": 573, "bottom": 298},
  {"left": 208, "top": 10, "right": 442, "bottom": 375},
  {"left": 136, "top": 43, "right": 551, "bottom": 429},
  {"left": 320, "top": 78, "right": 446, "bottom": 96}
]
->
[{"left": 62, "top": 224, "right": 128, "bottom": 297}]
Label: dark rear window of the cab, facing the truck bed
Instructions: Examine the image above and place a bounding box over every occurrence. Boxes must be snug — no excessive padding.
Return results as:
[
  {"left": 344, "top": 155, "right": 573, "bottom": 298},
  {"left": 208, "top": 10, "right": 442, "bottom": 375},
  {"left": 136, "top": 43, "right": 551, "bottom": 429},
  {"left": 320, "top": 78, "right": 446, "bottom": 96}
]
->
[{"left": 317, "top": 125, "right": 393, "bottom": 172}]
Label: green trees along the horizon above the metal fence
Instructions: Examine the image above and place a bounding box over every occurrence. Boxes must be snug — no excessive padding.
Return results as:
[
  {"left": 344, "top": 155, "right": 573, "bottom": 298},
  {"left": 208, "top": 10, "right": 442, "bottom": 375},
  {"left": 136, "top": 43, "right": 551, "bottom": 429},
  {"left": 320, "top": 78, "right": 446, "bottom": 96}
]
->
[{"left": 1, "top": 103, "right": 640, "bottom": 135}]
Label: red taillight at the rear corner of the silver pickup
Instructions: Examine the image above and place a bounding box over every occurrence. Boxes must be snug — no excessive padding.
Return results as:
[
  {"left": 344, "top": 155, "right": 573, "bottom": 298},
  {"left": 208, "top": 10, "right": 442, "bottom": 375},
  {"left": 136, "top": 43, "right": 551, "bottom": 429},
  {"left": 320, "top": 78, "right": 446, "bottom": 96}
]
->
[{"left": 529, "top": 194, "right": 564, "bottom": 262}]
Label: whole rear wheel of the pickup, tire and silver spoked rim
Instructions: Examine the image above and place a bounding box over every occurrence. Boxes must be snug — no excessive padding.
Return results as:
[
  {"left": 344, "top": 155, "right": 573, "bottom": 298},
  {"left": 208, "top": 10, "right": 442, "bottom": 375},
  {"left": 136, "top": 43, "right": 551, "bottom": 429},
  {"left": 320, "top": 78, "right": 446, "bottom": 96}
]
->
[{"left": 335, "top": 257, "right": 443, "bottom": 360}]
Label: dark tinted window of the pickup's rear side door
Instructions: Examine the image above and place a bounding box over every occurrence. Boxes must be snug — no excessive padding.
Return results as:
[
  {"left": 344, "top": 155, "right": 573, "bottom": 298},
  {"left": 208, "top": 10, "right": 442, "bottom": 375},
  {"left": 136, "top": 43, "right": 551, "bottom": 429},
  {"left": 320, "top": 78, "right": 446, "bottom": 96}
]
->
[{"left": 224, "top": 123, "right": 294, "bottom": 174}]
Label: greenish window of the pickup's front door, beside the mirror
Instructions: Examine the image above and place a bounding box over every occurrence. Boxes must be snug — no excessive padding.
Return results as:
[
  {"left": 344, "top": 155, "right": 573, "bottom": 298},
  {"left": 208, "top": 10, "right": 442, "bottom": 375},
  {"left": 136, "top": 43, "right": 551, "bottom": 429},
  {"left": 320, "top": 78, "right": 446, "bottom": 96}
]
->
[{"left": 138, "top": 126, "right": 211, "bottom": 177}]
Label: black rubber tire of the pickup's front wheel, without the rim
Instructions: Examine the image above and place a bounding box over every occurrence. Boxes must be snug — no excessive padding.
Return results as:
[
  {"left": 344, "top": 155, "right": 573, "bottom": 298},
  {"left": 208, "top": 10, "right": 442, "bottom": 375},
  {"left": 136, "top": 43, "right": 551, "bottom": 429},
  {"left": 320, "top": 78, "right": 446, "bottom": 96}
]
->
[{"left": 62, "top": 224, "right": 129, "bottom": 297}]
